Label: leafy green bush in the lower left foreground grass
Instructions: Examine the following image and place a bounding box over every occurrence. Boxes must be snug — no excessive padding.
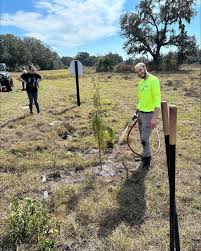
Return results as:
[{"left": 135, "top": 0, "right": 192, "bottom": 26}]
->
[{"left": 8, "top": 197, "right": 58, "bottom": 250}]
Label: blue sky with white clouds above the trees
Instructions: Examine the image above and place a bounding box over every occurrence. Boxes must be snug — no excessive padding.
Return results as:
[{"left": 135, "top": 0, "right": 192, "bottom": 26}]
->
[{"left": 0, "top": 0, "right": 201, "bottom": 59}]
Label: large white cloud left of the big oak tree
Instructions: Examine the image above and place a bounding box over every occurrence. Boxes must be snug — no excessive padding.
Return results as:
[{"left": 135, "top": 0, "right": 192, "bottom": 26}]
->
[{"left": 1, "top": 0, "right": 125, "bottom": 48}]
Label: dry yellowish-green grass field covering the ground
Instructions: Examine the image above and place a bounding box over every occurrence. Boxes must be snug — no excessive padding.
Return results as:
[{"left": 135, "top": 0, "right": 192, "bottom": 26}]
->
[{"left": 0, "top": 66, "right": 201, "bottom": 251}]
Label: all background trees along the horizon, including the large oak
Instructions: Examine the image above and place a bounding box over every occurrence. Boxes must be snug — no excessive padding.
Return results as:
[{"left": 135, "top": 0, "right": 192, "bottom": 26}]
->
[{"left": 0, "top": 0, "right": 200, "bottom": 72}]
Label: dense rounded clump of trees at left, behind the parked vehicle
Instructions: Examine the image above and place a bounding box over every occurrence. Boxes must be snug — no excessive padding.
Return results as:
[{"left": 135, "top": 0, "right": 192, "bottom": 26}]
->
[{"left": 0, "top": 34, "right": 63, "bottom": 70}]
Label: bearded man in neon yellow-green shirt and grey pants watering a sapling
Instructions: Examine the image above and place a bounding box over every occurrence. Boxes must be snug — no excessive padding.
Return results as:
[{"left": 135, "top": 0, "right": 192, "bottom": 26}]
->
[{"left": 135, "top": 62, "right": 161, "bottom": 168}]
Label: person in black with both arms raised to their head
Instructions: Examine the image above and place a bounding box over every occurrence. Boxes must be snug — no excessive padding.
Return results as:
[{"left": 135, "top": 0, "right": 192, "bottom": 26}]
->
[{"left": 20, "top": 65, "right": 43, "bottom": 114}]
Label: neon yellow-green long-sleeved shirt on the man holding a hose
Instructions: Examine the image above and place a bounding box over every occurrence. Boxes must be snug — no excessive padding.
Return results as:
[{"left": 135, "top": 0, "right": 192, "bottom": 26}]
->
[{"left": 137, "top": 74, "right": 161, "bottom": 112}]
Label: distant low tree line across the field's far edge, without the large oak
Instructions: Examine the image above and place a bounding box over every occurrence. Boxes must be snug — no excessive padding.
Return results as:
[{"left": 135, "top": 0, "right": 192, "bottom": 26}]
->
[{"left": 0, "top": 34, "right": 201, "bottom": 72}]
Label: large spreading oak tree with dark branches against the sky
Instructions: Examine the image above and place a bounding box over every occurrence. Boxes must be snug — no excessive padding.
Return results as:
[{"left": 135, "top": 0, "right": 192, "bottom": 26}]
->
[{"left": 120, "top": 0, "right": 196, "bottom": 70}]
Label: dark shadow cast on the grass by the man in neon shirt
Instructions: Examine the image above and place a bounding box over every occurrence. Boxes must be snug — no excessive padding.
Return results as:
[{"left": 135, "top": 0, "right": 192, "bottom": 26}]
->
[{"left": 98, "top": 168, "right": 148, "bottom": 237}]
